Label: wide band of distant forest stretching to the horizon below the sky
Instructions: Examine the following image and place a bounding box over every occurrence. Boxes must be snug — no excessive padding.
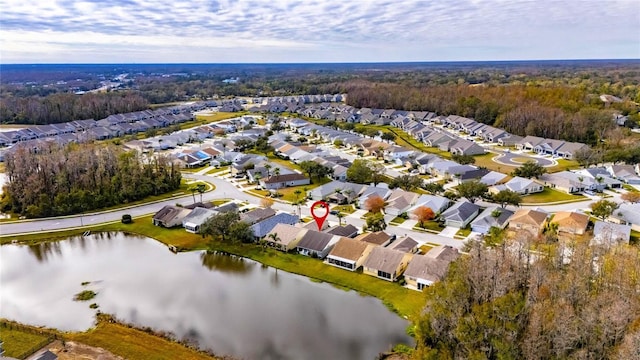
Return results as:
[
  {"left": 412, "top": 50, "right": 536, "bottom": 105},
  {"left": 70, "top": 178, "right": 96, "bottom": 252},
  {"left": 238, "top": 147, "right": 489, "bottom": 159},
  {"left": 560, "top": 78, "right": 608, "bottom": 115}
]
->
[{"left": 0, "top": 60, "right": 640, "bottom": 144}]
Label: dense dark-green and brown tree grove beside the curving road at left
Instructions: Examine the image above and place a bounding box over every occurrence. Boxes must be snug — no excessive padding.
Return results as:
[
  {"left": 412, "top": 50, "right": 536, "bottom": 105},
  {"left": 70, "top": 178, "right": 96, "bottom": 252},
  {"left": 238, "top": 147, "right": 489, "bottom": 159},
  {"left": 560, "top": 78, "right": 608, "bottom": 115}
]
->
[{"left": 0, "top": 144, "right": 181, "bottom": 217}]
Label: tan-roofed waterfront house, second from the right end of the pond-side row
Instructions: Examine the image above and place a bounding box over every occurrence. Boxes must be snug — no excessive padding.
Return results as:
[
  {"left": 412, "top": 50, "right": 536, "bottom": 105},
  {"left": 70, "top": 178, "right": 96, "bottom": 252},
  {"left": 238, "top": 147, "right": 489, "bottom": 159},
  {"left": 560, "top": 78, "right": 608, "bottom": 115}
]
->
[{"left": 363, "top": 246, "right": 413, "bottom": 281}]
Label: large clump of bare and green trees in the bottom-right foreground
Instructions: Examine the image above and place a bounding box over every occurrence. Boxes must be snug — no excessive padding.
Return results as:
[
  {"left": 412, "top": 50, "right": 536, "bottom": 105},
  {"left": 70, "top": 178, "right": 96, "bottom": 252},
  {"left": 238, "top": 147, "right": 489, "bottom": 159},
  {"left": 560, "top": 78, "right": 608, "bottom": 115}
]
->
[{"left": 414, "top": 239, "right": 640, "bottom": 360}]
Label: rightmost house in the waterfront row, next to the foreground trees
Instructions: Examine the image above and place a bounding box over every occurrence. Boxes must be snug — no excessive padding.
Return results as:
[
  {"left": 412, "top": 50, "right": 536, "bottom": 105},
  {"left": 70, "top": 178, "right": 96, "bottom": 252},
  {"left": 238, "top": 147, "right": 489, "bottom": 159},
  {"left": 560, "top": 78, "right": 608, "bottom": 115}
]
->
[{"left": 404, "top": 245, "right": 460, "bottom": 291}]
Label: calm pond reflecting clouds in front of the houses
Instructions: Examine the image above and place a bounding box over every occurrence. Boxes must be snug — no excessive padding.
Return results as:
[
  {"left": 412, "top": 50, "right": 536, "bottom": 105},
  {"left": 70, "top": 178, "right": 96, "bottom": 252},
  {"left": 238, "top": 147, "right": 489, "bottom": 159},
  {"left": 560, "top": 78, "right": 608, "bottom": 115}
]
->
[{"left": 0, "top": 233, "right": 413, "bottom": 359}]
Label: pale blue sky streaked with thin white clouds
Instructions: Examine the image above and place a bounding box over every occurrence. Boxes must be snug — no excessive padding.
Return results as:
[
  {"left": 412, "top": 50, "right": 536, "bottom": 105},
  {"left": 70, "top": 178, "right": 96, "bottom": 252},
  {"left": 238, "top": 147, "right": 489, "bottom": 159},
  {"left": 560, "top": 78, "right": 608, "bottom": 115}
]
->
[{"left": 0, "top": 0, "right": 640, "bottom": 64}]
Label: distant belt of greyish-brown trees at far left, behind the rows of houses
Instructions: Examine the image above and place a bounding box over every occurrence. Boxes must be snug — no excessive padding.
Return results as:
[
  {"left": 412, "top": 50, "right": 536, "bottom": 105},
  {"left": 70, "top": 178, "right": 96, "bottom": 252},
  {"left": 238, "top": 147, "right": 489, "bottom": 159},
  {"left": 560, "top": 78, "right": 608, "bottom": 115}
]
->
[{"left": 0, "top": 91, "right": 149, "bottom": 125}]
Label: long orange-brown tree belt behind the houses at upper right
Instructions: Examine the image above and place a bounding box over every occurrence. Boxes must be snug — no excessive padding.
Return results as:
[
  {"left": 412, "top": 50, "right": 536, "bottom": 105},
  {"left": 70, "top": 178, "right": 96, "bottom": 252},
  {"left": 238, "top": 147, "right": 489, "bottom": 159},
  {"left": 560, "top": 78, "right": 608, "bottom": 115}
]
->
[{"left": 345, "top": 81, "right": 631, "bottom": 144}]
